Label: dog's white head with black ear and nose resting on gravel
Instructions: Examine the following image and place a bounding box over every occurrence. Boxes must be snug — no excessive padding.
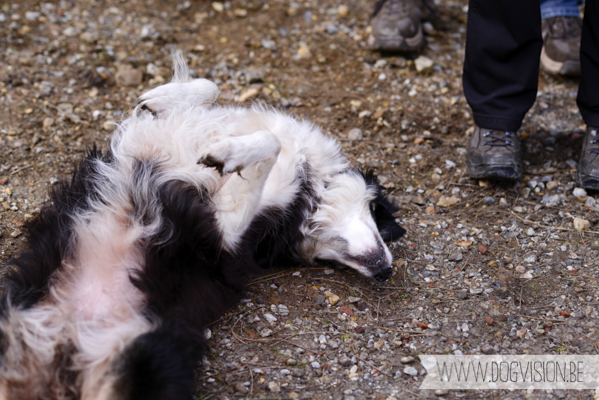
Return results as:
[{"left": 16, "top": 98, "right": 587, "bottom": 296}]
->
[{"left": 305, "top": 169, "right": 405, "bottom": 281}]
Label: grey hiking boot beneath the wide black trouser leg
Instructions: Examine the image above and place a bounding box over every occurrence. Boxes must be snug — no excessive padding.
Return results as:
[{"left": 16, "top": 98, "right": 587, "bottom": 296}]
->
[{"left": 467, "top": 126, "right": 522, "bottom": 180}]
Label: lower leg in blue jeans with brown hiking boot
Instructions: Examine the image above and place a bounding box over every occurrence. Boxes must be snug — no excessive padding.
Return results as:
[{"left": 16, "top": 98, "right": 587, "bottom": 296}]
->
[{"left": 541, "top": 0, "right": 582, "bottom": 76}]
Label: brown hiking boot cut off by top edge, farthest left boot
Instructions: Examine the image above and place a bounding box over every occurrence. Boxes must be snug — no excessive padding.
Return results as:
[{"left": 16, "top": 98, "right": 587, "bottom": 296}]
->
[{"left": 368, "top": 0, "right": 437, "bottom": 51}]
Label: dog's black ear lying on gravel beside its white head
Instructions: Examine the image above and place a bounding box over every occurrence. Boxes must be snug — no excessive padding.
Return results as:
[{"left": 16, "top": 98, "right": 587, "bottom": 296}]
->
[{"left": 361, "top": 170, "right": 406, "bottom": 242}]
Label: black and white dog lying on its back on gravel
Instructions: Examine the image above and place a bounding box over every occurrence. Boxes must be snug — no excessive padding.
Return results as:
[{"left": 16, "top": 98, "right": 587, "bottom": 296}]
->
[{"left": 0, "top": 60, "right": 405, "bottom": 400}]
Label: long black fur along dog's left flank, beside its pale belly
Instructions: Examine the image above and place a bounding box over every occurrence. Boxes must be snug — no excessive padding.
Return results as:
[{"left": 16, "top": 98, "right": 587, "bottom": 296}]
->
[{"left": 0, "top": 147, "right": 111, "bottom": 315}]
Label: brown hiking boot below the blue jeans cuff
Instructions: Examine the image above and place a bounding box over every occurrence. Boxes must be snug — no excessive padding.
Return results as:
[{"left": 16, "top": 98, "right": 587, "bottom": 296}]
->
[{"left": 541, "top": 17, "right": 582, "bottom": 76}]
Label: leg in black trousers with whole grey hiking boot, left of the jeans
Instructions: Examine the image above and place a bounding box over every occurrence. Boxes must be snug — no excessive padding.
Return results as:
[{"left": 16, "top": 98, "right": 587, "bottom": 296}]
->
[{"left": 463, "top": 0, "right": 543, "bottom": 179}]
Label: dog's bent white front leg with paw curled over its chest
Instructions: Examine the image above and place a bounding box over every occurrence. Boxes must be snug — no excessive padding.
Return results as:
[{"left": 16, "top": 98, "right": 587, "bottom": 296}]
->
[{"left": 198, "top": 131, "right": 281, "bottom": 249}]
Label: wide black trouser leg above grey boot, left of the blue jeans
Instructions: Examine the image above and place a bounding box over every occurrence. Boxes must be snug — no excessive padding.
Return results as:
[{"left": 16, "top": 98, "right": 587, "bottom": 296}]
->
[{"left": 463, "top": 0, "right": 548, "bottom": 131}]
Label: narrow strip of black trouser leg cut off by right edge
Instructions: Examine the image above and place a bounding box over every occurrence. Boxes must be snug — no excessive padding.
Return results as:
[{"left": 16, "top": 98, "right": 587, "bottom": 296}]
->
[{"left": 577, "top": 0, "right": 599, "bottom": 127}]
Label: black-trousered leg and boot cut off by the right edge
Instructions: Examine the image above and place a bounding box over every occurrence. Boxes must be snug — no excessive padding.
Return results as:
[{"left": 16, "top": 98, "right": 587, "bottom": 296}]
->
[{"left": 577, "top": 1, "right": 599, "bottom": 190}]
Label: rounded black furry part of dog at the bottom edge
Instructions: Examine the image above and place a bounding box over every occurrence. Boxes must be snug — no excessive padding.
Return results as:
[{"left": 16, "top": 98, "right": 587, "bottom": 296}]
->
[{"left": 116, "top": 323, "right": 204, "bottom": 400}]
